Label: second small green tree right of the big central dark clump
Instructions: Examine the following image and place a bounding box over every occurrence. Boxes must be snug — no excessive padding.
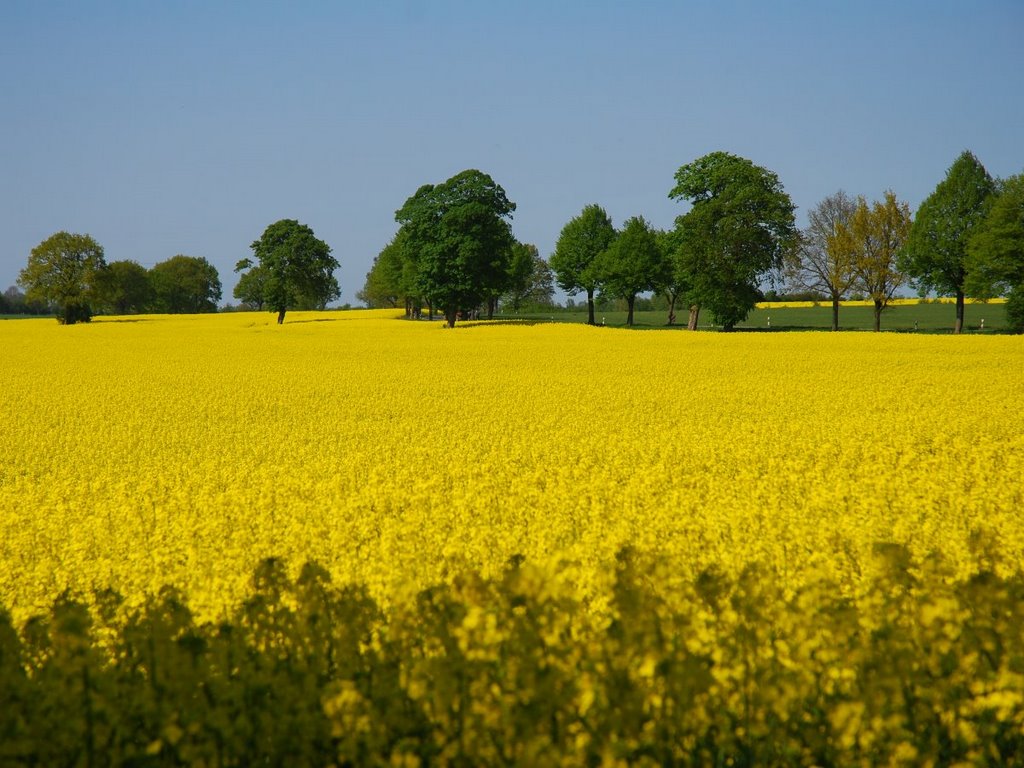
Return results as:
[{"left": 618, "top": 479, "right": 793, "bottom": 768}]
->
[{"left": 597, "top": 216, "right": 671, "bottom": 327}]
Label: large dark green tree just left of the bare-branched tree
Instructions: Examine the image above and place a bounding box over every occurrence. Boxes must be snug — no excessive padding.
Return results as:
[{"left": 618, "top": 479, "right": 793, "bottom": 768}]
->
[{"left": 669, "top": 152, "right": 797, "bottom": 331}]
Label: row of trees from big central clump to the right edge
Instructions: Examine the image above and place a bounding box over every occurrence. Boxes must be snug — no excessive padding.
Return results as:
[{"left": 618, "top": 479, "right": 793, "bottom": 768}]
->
[{"left": 358, "top": 152, "right": 1024, "bottom": 333}]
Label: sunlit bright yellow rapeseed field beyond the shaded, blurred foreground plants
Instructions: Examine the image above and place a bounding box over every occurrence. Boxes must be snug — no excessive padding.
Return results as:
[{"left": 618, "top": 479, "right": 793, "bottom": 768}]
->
[{"left": 0, "top": 311, "right": 1024, "bottom": 621}]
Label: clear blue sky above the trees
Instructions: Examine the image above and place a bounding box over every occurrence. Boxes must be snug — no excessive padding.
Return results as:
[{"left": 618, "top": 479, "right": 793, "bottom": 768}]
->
[{"left": 0, "top": 0, "right": 1024, "bottom": 303}]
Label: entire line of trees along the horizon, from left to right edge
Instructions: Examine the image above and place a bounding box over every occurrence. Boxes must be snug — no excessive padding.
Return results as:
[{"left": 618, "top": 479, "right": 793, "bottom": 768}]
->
[{"left": 16, "top": 152, "right": 1024, "bottom": 333}]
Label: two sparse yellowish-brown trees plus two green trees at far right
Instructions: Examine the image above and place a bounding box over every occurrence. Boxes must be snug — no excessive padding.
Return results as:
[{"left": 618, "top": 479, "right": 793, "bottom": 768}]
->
[{"left": 784, "top": 152, "right": 1024, "bottom": 333}]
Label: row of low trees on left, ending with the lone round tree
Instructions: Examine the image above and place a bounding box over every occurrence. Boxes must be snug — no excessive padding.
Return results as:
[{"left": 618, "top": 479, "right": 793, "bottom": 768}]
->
[{"left": 14, "top": 219, "right": 340, "bottom": 325}]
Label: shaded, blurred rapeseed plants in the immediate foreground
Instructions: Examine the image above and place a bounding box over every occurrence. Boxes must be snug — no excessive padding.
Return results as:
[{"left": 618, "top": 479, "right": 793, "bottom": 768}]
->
[{"left": 6, "top": 545, "right": 1024, "bottom": 766}]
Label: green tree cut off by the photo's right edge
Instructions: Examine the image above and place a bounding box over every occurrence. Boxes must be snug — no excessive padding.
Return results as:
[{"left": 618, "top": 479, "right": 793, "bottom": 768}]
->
[{"left": 967, "top": 173, "right": 1024, "bottom": 331}]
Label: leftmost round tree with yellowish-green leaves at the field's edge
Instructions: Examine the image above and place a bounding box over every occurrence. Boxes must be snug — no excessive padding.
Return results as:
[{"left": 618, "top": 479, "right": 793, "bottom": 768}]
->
[{"left": 17, "top": 231, "right": 106, "bottom": 326}]
